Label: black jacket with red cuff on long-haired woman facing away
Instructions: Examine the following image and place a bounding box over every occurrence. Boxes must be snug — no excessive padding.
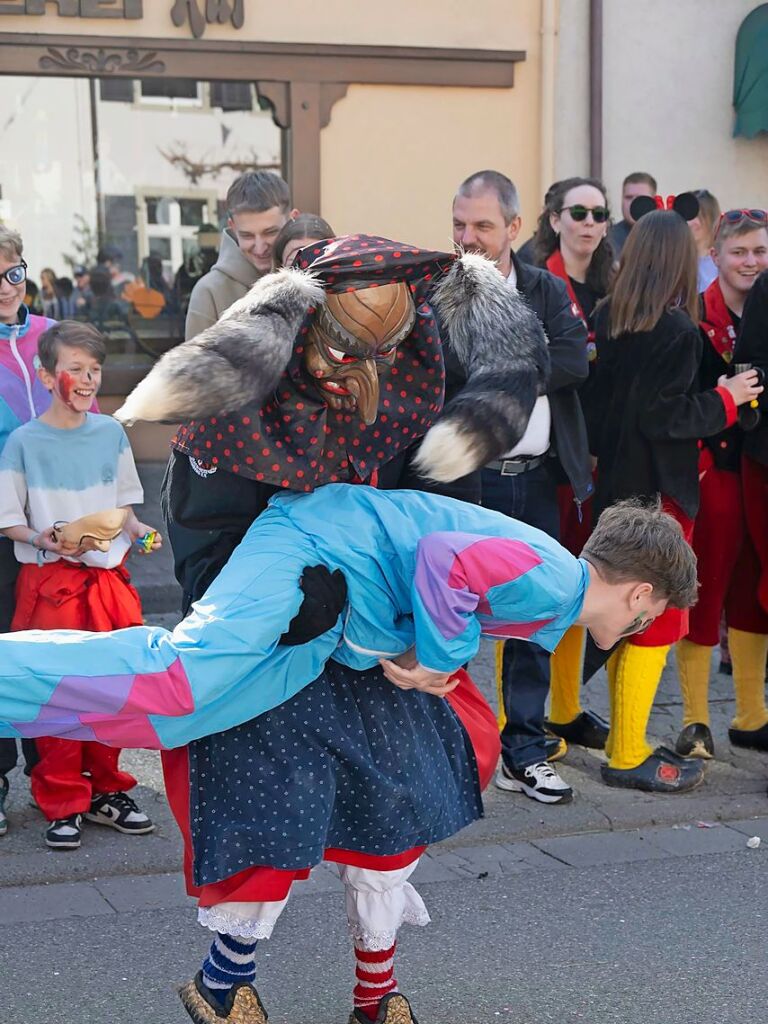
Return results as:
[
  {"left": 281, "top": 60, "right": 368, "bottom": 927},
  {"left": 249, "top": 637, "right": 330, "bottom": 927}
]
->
[{"left": 586, "top": 304, "right": 736, "bottom": 518}]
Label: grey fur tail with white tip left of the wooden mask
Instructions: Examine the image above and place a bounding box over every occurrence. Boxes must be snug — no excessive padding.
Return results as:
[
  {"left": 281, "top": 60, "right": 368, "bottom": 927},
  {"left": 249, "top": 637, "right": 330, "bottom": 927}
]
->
[{"left": 115, "top": 269, "right": 325, "bottom": 424}]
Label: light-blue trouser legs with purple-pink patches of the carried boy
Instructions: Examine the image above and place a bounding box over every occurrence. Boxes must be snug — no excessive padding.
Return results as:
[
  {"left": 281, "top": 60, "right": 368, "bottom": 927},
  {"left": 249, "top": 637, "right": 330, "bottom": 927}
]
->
[{"left": 0, "top": 512, "right": 341, "bottom": 749}]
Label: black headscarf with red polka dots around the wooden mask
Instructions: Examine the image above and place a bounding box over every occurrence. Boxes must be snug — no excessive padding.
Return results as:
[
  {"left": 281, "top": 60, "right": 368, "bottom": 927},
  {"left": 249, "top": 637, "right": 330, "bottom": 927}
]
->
[{"left": 172, "top": 234, "right": 456, "bottom": 490}]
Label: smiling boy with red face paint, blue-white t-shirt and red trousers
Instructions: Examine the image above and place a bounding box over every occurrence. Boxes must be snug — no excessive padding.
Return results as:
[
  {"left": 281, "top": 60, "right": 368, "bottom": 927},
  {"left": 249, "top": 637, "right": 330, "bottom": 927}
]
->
[{"left": 0, "top": 321, "right": 161, "bottom": 850}]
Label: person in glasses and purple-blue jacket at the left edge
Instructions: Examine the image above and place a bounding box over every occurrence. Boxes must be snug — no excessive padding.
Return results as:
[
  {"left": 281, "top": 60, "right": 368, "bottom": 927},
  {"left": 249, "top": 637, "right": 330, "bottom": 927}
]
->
[{"left": 0, "top": 224, "right": 54, "bottom": 836}]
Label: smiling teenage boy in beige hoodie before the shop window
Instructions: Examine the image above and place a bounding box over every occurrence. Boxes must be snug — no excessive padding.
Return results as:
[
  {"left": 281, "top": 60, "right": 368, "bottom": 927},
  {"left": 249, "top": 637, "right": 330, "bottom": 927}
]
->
[{"left": 184, "top": 171, "right": 298, "bottom": 341}]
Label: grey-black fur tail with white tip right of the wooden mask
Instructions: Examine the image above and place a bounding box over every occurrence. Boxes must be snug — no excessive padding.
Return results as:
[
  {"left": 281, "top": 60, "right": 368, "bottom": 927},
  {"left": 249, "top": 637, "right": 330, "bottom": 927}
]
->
[{"left": 415, "top": 253, "right": 550, "bottom": 482}]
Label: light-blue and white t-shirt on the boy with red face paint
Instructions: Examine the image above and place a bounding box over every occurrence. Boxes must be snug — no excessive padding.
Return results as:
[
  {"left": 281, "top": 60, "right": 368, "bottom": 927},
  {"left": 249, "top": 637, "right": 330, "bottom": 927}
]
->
[{"left": 0, "top": 413, "right": 144, "bottom": 568}]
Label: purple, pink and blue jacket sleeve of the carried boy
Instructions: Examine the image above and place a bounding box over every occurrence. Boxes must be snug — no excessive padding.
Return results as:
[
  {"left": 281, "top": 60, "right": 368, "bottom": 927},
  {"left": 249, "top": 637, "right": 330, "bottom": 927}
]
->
[{"left": 413, "top": 532, "right": 586, "bottom": 672}]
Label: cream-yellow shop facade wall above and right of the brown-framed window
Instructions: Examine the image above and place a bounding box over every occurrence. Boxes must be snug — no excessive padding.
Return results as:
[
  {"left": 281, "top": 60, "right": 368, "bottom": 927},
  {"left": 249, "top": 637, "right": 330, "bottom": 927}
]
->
[{"left": 0, "top": 0, "right": 541, "bottom": 249}]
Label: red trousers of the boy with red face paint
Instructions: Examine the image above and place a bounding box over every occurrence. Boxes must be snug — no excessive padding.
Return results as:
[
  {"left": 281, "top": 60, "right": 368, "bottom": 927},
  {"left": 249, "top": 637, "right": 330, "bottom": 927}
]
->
[{"left": 11, "top": 561, "right": 142, "bottom": 821}]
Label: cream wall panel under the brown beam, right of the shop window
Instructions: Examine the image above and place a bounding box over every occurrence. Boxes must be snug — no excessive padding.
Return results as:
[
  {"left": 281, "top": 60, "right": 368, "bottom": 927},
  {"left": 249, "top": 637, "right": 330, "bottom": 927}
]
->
[{"left": 322, "top": 78, "right": 540, "bottom": 249}]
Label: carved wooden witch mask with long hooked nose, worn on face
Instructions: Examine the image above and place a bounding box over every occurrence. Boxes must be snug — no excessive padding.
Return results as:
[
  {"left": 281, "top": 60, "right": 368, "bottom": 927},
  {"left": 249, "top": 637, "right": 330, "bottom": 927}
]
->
[{"left": 304, "top": 282, "right": 416, "bottom": 424}]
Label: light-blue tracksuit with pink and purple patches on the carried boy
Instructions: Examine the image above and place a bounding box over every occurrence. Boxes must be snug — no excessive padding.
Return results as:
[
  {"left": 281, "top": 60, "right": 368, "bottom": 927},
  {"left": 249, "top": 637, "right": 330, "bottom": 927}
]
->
[{"left": 0, "top": 484, "right": 589, "bottom": 748}]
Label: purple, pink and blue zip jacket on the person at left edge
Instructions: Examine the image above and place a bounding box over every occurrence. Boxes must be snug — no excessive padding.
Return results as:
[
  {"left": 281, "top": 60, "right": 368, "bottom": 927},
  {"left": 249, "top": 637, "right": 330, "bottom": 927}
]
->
[{"left": 0, "top": 306, "right": 55, "bottom": 452}]
